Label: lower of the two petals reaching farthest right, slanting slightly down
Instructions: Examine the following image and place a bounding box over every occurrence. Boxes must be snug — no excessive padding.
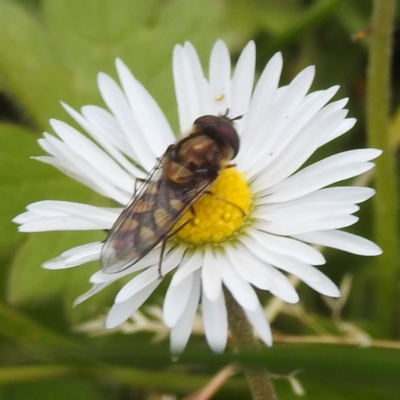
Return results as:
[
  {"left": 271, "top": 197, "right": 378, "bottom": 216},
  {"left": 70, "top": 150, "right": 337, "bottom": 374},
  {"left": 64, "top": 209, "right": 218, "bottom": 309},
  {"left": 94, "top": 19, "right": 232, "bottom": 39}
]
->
[{"left": 296, "top": 230, "right": 382, "bottom": 256}]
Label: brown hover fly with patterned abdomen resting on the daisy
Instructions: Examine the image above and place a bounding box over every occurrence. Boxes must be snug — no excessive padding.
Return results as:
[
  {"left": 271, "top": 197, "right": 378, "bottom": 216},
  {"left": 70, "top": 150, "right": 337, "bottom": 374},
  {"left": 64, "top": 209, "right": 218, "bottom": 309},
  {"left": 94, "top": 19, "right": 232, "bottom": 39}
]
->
[{"left": 101, "top": 115, "right": 239, "bottom": 276}]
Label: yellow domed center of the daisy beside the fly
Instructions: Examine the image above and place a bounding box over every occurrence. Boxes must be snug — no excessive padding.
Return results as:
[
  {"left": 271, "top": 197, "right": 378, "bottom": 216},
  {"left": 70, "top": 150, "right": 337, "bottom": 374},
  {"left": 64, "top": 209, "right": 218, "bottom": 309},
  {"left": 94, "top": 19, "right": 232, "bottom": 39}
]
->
[{"left": 174, "top": 167, "right": 251, "bottom": 245}]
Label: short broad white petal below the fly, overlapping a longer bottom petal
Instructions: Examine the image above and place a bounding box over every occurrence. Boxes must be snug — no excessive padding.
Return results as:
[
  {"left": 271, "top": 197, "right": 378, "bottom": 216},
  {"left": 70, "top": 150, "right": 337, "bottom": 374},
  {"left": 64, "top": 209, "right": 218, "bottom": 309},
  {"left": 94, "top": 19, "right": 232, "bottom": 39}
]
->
[{"left": 163, "top": 274, "right": 193, "bottom": 328}]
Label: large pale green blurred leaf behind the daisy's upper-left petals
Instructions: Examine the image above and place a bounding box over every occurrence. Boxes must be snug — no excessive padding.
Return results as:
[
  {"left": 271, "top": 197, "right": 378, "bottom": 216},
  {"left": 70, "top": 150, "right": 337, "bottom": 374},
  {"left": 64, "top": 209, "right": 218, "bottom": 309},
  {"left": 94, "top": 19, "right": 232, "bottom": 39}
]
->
[{"left": 39, "top": 0, "right": 248, "bottom": 129}]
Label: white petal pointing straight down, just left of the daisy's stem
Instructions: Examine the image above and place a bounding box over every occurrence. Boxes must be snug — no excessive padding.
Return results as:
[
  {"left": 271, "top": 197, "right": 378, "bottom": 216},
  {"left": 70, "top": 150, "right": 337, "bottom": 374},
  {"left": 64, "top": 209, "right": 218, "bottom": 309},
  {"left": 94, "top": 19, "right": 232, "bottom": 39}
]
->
[{"left": 201, "top": 292, "right": 228, "bottom": 353}]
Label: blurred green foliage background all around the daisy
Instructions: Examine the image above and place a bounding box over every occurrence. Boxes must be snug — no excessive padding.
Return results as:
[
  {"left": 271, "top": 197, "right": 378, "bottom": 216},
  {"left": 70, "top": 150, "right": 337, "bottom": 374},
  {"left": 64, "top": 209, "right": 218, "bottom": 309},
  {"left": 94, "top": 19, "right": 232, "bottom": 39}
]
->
[{"left": 0, "top": 0, "right": 400, "bottom": 400}]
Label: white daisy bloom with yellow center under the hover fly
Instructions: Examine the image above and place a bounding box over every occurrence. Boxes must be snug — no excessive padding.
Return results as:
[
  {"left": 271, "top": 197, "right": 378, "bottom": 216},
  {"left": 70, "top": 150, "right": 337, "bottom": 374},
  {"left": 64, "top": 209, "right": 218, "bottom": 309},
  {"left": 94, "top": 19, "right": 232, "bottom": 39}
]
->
[{"left": 14, "top": 41, "right": 381, "bottom": 353}]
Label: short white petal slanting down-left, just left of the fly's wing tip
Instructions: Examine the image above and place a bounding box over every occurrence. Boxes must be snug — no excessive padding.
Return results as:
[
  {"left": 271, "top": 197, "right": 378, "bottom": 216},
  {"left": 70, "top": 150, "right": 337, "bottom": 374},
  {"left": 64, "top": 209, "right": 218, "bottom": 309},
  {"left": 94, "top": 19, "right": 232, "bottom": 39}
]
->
[{"left": 42, "top": 242, "right": 103, "bottom": 269}]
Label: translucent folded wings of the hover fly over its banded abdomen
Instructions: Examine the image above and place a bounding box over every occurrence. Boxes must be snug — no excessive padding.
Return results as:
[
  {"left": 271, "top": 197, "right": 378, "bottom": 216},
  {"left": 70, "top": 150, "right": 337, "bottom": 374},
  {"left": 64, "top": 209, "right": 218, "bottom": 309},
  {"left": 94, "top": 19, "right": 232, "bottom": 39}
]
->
[{"left": 101, "top": 163, "right": 212, "bottom": 273}]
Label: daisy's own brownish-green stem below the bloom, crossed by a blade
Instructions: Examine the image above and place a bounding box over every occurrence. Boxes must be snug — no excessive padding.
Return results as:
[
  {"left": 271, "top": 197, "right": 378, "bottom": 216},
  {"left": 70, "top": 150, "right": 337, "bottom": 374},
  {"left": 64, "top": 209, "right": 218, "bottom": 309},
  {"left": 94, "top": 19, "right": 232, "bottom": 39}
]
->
[{"left": 225, "top": 290, "right": 278, "bottom": 400}]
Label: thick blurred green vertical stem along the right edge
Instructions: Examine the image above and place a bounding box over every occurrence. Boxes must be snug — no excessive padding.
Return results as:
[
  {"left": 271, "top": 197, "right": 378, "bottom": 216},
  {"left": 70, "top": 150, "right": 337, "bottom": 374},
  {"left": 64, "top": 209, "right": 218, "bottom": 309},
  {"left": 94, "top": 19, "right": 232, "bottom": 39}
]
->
[{"left": 367, "top": 0, "right": 399, "bottom": 337}]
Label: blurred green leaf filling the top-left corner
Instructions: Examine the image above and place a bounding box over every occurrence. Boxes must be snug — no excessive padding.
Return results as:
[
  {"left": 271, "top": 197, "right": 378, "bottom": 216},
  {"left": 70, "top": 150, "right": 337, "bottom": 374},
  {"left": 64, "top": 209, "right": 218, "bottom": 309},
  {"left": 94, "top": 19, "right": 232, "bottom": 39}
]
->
[{"left": 0, "top": 0, "right": 71, "bottom": 129}]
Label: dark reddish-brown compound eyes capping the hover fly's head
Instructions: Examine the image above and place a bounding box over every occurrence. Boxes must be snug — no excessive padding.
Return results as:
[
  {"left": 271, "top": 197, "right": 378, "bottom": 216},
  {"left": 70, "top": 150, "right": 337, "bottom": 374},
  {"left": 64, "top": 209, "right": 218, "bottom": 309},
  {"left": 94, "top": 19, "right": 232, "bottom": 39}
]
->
[{"left": 194, "top": 115, "right": 240, "bottom": 159}]
